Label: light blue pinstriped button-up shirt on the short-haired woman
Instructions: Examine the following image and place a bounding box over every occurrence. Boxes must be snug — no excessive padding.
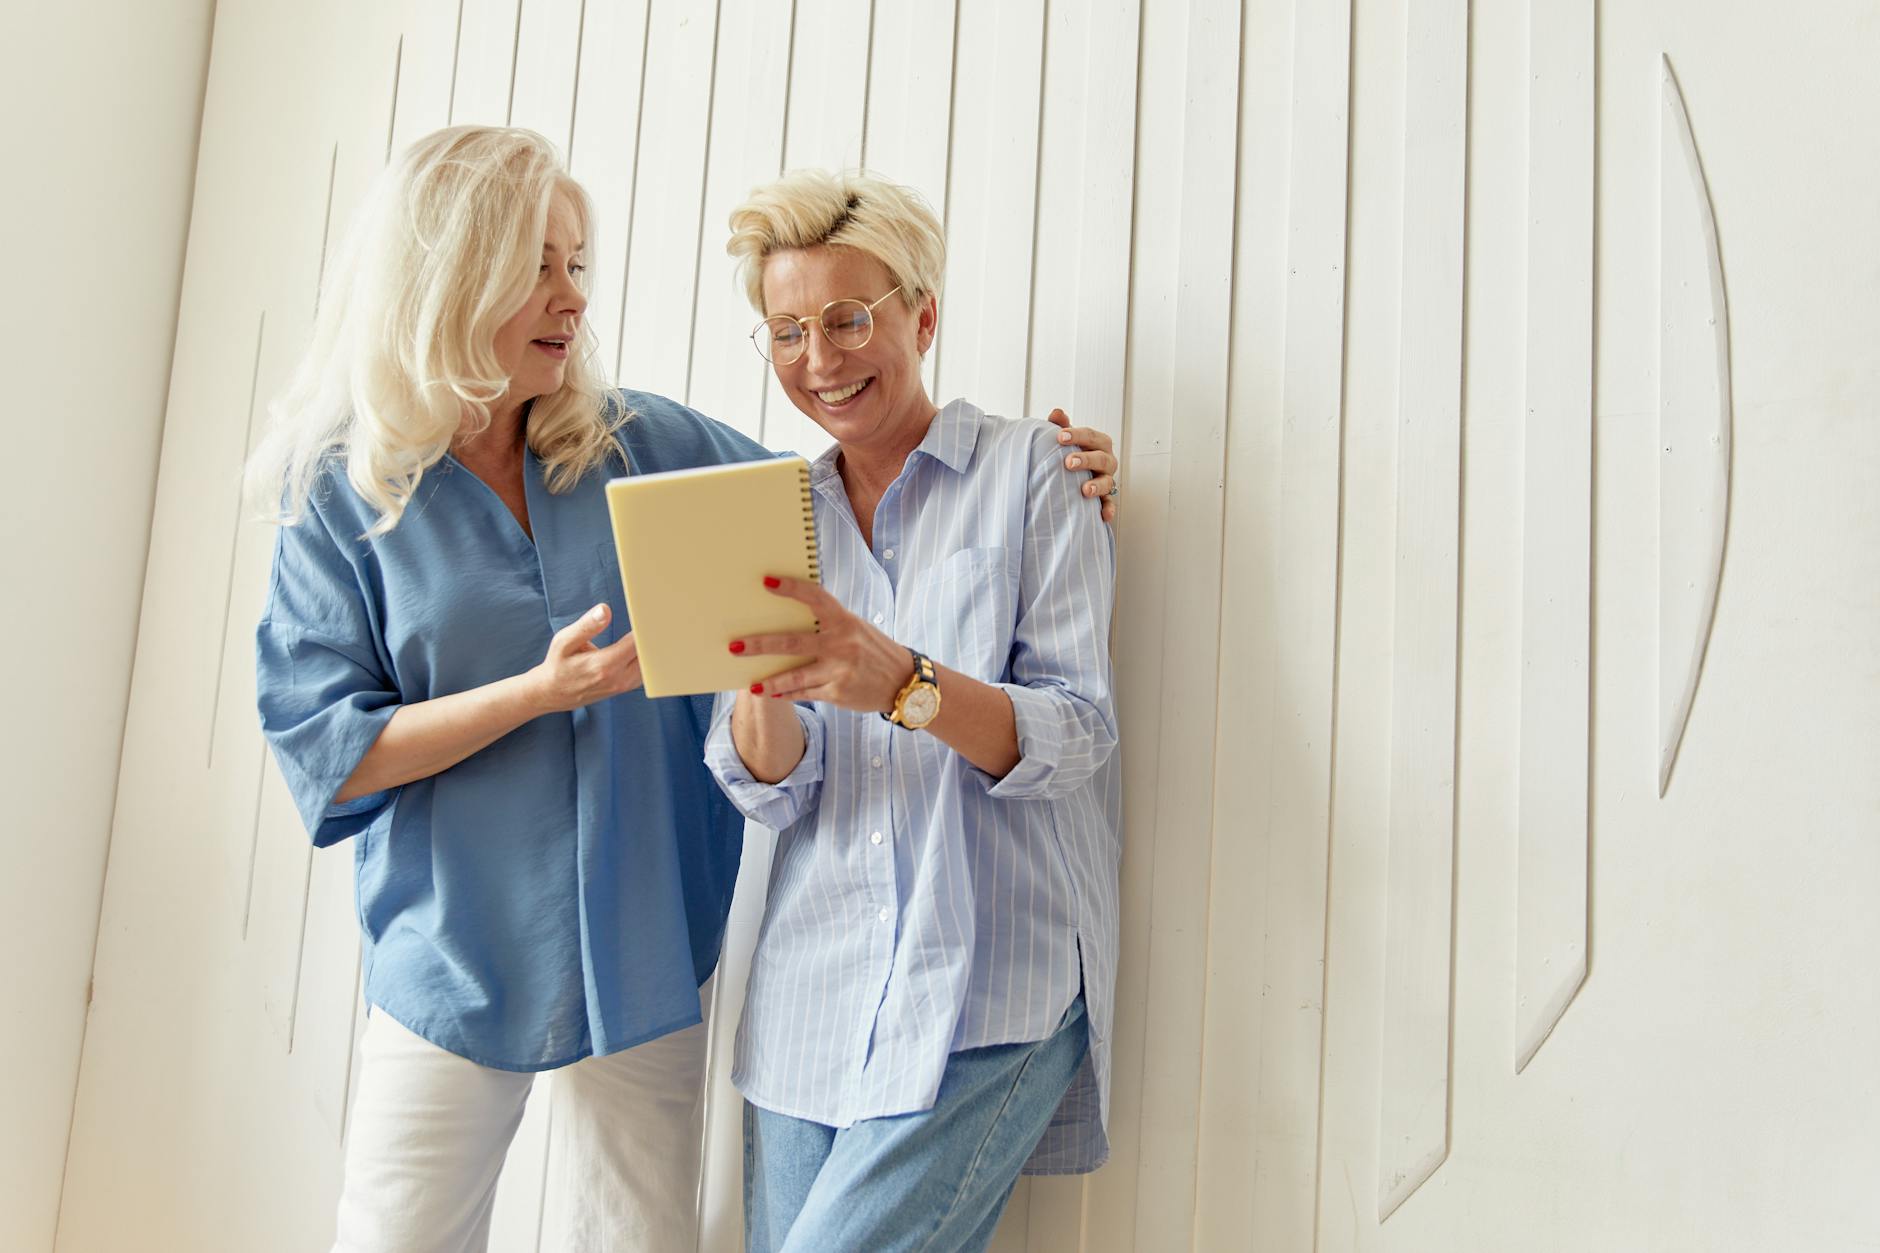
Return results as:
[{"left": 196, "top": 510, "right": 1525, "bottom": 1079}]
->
[{"left": 707, "top": 401, "right": 1120, "bottom": 1174}]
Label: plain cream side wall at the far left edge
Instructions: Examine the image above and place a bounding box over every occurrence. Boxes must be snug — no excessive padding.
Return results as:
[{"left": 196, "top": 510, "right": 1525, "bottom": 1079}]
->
[{"left": 0, "top": 0, "right": 215, "bottom": 1253}]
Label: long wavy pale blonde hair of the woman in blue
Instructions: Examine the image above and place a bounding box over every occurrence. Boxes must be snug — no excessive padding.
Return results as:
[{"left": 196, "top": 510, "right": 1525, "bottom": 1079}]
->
[{"left": 246, "top": 126, "right": 624, "bottom": 534}]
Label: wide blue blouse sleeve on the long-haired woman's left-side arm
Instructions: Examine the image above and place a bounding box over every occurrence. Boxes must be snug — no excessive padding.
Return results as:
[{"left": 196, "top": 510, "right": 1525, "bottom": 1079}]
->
[{"left": 256, "top": 510, "right": 400, "bottom": 849}]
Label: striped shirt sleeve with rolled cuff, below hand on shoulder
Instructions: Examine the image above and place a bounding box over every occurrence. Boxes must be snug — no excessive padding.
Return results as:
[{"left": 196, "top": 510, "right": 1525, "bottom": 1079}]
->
[{"left": 974, "top": 435, "right": 1117, "bottom": 800}]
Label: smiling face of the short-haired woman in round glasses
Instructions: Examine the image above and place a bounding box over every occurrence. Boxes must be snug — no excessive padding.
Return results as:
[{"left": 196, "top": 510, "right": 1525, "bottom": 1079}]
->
[{"left": 763, "top": 245, "right": 938, "bottom": 455}]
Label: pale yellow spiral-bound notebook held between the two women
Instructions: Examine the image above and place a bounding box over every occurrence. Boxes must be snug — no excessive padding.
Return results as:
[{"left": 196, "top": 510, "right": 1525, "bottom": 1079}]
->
[{"left": 607, "top": 457, "right": 822, "bottom": 696}]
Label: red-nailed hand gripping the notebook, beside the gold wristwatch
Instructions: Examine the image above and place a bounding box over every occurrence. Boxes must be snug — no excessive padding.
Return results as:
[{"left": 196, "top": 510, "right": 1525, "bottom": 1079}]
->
[{"left": 731, "top": 578, "right": 914, "bottom": 713}]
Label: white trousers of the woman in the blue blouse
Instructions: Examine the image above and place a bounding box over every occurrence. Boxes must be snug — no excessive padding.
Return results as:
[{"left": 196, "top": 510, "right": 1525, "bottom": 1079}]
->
[{"left": 333, "top": 984, "right": 711, "bottom": 1253}]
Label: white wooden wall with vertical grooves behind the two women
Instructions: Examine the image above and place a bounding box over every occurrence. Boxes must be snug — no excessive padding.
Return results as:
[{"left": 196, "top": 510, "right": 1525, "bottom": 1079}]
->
[{"left": 58, "top": 0, "right": 1880, "bottom": 1253}]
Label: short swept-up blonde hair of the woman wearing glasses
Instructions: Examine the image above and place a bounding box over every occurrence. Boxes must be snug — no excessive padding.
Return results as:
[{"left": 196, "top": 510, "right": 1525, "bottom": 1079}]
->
[{"left": 724, "top": 169, "right": 946, "bottom": 312}]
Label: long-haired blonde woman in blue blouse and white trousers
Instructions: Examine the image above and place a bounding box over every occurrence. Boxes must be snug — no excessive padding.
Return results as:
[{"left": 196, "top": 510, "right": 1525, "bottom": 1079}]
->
[{"left": 248, "top": 126, "right": 1115, "bottom": 1251}]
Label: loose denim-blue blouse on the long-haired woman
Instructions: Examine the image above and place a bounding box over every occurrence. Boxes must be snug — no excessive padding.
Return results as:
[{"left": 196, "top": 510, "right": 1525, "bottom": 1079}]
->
[{"left": 256, "top": 391, "right": 773, "bottom": 1071}]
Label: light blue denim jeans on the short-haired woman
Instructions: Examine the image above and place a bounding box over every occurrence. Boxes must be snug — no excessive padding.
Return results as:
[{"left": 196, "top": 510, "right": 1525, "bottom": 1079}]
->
[{"left": 744, "top": 995, "right": 1090, "bottom": 1253}]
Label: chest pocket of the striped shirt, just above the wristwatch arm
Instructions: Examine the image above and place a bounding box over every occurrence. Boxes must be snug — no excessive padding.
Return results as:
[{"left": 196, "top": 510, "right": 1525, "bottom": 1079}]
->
[{"left": 897, "top": 547, "right": 1019, "bottom": 683}]
